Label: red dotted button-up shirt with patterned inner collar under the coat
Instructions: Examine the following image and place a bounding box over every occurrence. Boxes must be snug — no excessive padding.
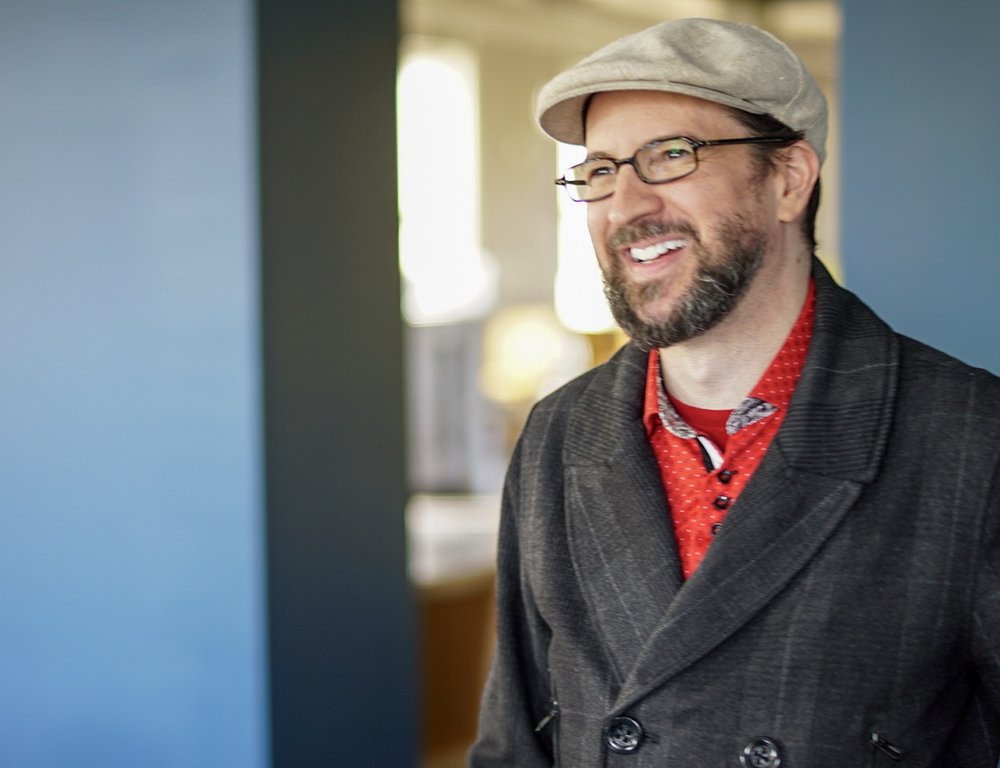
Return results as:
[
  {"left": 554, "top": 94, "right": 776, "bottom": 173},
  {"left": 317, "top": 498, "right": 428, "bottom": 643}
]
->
[{"left": 643, "top": 281, "right": 816, "bottom": 579}]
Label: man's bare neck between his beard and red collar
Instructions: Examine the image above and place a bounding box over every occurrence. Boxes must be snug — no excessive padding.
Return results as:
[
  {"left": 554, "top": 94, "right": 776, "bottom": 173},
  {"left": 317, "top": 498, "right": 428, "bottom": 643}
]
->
[{"left": 659, "top": 252, "right": 810, "bottom": 410}]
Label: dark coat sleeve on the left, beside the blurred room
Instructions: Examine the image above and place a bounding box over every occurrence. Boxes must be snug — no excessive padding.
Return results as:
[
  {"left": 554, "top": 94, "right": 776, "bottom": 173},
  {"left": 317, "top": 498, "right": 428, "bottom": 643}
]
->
[{"left": 469, "top": 438, "right": 557, "bottom": 768}]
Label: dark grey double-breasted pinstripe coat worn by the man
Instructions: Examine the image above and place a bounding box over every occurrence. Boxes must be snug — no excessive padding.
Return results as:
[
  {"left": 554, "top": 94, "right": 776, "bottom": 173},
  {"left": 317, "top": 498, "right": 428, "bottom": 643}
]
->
[{"left": 470, "top": 262, "right": 1000, "bottom": 768}]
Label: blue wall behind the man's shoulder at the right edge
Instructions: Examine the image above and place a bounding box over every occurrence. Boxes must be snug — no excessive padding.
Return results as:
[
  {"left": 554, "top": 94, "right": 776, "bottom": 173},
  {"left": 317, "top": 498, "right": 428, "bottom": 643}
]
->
[{"left": 841, "top": 0, "right": 1000, "bottom": 373}]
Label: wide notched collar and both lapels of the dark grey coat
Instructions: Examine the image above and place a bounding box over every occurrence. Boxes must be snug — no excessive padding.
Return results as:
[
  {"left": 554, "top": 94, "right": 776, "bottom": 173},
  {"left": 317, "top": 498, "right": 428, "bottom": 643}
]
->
[{"left": 564, "top": 261, "right": 898, "bottom": 711}]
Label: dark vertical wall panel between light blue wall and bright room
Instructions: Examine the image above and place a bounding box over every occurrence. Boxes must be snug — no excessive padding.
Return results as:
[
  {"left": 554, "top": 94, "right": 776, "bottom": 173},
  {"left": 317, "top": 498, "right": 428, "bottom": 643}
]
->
[{"left": 257, "top": 0, "right": 417, "bottom": 768}]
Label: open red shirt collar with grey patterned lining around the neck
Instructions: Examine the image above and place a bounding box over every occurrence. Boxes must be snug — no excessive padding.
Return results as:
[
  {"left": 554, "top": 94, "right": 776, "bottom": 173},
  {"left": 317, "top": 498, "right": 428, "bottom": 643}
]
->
[{"left": 643, "top": 278, "right": 816, "bottom": 438}]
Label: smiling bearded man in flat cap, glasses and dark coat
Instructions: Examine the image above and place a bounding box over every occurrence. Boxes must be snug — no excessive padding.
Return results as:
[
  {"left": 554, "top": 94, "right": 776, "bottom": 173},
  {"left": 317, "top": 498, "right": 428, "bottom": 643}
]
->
[{"left": 471, "top": 19, "right": 1000, "bottom": 768}]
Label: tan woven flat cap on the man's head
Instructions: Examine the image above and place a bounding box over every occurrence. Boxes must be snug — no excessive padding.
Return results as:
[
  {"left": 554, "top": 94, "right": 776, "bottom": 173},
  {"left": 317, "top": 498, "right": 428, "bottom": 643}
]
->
[{"left": 537, "top": 19, "right": 826, "bottom": 161}]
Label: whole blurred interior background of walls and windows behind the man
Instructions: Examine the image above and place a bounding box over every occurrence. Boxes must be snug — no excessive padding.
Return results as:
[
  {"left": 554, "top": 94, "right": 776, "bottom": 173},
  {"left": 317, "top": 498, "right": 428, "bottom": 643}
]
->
[{"left": 0, "top": 0, "right": 1000, "bottom": 768}]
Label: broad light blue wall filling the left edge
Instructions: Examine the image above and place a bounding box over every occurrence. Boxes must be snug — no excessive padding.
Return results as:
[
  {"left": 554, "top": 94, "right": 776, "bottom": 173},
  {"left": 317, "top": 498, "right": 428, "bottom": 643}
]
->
[{"left": 0, "top": 0, "right": 267, "bottom": 768}]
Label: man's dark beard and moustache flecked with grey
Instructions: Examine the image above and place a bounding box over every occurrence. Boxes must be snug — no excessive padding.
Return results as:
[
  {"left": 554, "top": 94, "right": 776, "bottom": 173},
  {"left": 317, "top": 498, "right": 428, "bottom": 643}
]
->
[{"left": 602, "top": 214, "right": 768, "bottom": 351}]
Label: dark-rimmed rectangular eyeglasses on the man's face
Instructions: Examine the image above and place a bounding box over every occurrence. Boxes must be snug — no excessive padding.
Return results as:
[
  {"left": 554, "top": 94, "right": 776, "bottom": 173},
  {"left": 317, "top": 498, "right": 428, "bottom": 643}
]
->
[{"left": 556, "top": 134, "right": 802, "bottom": 203}]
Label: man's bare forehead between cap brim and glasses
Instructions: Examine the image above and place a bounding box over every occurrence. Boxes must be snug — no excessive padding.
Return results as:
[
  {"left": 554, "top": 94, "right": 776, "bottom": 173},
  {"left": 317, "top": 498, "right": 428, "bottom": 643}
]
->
[{"left": 585, "top": 91, "right": 740, "bottom": 152}]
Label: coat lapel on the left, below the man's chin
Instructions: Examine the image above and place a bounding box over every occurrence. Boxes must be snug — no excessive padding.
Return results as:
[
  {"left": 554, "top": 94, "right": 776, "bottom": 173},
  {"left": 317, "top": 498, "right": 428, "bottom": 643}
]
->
[{"left": 565, "top": 347, "right": 682, "bottom": 685}]
